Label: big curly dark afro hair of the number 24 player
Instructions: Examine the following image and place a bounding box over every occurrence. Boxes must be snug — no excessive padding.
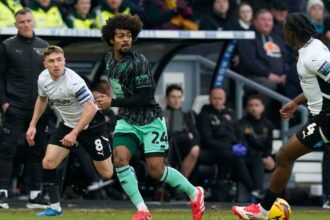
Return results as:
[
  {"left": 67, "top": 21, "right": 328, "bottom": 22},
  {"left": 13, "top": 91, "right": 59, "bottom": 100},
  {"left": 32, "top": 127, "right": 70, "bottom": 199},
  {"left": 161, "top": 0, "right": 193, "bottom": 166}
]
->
[{"left": 101, "top": 14, "right": 143, "bottom": 46}]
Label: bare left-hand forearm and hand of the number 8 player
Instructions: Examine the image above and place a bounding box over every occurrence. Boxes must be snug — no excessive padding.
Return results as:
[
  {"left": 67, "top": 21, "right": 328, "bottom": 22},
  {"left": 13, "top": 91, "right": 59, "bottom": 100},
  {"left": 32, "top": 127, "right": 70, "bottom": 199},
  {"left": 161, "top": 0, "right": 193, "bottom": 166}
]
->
[{"left": 26, "top": 96, "right": 48, "bottom": 146}]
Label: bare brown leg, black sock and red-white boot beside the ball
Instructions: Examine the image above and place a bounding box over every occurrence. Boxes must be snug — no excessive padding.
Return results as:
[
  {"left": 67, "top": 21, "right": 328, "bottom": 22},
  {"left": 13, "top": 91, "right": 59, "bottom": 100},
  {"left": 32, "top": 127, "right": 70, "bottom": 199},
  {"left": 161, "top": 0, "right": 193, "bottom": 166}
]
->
[{"left": 232, "top": 135, "right": 312, "bottom": 220}]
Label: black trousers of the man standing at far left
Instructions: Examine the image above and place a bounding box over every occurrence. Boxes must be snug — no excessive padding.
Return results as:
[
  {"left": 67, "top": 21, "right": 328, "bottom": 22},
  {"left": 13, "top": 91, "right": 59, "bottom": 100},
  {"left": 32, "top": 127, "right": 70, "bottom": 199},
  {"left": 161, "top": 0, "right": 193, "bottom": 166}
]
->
[{"left": 0, "top": 106, "right": 48, "bottom": 190}]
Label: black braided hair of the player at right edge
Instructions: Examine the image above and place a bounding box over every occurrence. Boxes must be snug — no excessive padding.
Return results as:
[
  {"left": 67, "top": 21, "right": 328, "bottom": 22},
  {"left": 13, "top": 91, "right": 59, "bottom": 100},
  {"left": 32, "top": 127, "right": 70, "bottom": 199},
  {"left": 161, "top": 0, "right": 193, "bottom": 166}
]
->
[{"left": 285, "top": 13, "right": 316, "bottom": 43}]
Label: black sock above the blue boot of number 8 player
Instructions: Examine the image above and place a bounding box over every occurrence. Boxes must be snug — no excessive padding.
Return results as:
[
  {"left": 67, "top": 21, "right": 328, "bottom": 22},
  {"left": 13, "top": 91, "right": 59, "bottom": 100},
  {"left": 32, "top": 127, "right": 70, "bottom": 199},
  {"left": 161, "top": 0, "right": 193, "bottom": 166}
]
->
[{"left": 43, "top": 169, "right": 61, "bottom": 204}]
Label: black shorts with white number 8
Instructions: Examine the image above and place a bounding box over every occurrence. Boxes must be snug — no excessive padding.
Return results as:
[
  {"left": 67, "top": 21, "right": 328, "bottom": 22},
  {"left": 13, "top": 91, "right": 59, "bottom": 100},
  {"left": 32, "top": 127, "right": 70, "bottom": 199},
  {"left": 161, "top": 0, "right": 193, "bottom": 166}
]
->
[{"left": 48, "top": 123, "right": 111, "bottom": 161}]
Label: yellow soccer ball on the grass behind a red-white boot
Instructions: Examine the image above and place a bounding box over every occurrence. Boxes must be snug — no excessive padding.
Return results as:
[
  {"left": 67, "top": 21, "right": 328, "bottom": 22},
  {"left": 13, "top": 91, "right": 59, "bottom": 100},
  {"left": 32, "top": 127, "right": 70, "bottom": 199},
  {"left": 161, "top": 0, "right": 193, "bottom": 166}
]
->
[{"left": 269, "top": 198, "right": 291, "bottom": 220}]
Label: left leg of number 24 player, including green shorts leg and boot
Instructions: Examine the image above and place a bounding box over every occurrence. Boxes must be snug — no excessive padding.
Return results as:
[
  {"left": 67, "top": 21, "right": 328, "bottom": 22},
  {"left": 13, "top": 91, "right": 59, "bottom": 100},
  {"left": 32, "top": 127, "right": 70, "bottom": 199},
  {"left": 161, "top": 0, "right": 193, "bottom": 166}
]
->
[{"left": 113, "top": 120, "right": 152, "bottom": 220}]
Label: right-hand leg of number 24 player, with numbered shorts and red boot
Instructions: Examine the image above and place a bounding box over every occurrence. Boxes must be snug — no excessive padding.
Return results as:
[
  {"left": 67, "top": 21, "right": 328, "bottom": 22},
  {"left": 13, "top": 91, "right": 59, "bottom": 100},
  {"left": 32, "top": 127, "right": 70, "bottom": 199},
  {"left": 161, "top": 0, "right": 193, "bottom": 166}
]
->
[{"left": 143, "top": 118, "right": 205, "bottom": 220}]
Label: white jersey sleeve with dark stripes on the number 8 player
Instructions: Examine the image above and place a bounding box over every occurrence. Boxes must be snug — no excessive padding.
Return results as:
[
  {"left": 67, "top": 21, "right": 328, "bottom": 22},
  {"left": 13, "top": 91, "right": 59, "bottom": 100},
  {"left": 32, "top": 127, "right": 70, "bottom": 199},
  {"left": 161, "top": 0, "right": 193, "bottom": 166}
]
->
[{"left": 72, "top": 77, "right": 94, "bottom": 105}]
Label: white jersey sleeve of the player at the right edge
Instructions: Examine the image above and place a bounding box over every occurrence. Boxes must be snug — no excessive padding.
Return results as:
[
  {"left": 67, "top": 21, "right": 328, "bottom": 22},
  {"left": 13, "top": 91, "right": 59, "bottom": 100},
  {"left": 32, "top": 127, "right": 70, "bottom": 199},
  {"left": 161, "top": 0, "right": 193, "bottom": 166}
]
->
[{"left": 304, "top": 53, "right": 330, "bottom": 82}]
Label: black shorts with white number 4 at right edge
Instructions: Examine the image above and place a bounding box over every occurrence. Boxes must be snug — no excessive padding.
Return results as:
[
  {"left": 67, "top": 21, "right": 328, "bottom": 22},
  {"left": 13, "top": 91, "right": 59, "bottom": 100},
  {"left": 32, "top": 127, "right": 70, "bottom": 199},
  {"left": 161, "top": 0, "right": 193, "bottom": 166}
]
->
[{"left": 297, "top": 111, "right": 330, "bottom": 150}]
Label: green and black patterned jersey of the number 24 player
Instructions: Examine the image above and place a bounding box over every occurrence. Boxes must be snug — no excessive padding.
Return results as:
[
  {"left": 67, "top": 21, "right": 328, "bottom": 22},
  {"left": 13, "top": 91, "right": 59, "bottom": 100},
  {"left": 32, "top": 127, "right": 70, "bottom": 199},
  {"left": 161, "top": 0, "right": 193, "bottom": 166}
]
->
[{"left": 105, "top": 51, "right": 162, "bottom": 126}]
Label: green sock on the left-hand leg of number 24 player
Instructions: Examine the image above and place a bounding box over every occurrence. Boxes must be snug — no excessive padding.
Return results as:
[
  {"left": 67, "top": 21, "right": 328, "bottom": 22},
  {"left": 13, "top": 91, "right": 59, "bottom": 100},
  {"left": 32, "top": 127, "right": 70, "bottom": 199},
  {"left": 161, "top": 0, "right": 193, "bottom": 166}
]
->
[{"left": 116, "top": 166, "right": 144, "bottom": 206}]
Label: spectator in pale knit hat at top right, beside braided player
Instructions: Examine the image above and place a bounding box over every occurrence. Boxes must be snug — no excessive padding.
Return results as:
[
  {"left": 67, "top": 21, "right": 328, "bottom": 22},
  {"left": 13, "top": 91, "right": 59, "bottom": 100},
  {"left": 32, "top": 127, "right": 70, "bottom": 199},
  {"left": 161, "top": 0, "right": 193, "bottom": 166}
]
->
[{"left": 307, "top": 0, "right": 324, "bottom": 37}]
